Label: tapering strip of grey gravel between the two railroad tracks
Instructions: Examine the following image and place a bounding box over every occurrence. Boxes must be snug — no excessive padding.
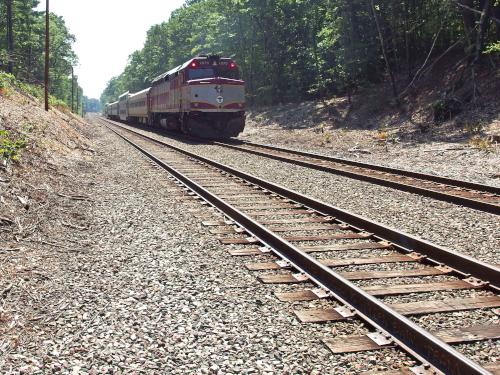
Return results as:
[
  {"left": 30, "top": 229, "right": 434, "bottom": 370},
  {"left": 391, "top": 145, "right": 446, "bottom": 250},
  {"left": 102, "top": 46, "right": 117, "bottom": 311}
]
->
[{"left": 113, "top": 125, "right": 500, "bottom": 264}]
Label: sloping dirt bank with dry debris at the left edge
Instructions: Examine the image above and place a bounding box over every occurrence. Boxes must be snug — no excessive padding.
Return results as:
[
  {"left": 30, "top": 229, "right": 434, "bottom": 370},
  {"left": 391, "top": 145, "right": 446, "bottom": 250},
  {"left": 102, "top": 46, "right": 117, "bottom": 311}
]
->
[{"left": 0, "top": 89, "right": 94, "bottom": 252}]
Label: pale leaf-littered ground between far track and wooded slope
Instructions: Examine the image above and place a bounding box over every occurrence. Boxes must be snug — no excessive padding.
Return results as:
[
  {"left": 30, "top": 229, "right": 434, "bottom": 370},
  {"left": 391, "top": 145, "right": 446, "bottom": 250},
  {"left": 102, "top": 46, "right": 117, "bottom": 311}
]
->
[{"left": 238, "top": 112, "right": 500, "bottom": 187}]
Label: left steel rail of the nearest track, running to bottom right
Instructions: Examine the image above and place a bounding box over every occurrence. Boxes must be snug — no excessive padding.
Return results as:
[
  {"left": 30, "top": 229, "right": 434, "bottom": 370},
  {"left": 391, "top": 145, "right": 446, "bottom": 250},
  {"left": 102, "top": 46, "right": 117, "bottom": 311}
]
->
[{"left": 102, "top": 122, "right": 496, "bottom": 374}]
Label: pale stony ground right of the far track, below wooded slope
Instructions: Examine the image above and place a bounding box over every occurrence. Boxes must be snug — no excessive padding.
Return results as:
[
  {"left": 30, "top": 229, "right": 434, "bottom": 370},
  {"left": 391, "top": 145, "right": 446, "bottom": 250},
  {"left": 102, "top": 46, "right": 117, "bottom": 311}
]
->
[{"left": 240, "top": 119, "right": 500, "bottom": 186}]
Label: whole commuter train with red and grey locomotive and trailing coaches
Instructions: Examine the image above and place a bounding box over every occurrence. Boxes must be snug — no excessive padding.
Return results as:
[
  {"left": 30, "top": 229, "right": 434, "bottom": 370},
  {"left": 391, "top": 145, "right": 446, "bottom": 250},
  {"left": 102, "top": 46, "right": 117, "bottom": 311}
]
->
[{"left": 104, "top": 55, "right": 245, "bottom": 138}]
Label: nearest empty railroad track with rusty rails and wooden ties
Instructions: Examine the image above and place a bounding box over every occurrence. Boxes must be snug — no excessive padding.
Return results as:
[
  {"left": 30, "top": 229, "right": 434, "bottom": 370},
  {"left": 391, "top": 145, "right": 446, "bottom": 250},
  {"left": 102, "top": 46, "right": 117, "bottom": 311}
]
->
[{"left": 100, "top": 120, "right": 500, "bottom": 374}]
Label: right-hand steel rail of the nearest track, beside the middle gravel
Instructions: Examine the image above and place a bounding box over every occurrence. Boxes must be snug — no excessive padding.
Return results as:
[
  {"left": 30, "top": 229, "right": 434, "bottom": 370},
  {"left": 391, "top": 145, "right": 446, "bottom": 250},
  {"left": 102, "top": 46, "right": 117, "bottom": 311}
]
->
[{"left": 101, "top": 119, "right": 500, "bottom": 289}]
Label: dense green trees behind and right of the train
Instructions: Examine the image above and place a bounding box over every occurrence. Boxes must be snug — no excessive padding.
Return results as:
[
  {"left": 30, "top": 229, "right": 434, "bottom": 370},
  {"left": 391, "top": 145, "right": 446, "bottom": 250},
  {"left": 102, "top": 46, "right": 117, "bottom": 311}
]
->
[{"left": 101, "top": 0, "right": 500, "bottom": 104}]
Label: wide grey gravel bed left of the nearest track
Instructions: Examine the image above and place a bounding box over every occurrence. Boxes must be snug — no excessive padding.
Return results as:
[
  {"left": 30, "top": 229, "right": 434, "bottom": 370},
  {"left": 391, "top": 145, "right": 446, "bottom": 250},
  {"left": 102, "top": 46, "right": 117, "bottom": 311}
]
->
[{"left": 0, "top": 121, "right": 422, "bottom": 374}]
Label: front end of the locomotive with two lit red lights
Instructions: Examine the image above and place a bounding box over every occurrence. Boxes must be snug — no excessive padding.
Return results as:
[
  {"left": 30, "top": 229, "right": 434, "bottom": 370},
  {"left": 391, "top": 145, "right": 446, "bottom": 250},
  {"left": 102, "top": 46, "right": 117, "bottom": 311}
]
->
[{"left": 182, "top": 57, "right": 245, "bottom": 138}]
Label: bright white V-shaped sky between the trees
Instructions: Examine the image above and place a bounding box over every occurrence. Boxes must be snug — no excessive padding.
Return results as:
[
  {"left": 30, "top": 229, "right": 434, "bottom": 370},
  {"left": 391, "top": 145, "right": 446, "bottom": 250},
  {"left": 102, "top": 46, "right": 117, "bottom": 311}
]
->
[{"left": 39, "top": 0, "right": 184, "bottom": 98}]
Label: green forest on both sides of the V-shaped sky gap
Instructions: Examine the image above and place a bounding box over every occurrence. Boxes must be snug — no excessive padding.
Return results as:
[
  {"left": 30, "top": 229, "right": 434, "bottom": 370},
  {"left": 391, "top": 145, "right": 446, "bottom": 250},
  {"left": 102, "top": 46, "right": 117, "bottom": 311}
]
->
[{"left": 0, "top": 0, "right": 500, "bottom": 117}]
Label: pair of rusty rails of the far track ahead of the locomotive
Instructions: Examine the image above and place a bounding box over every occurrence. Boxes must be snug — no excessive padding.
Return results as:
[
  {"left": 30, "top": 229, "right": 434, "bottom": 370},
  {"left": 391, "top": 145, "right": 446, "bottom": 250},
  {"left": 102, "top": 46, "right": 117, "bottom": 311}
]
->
[{"left": 213, "top": 141, "right": 500, "bottom": 215}]
